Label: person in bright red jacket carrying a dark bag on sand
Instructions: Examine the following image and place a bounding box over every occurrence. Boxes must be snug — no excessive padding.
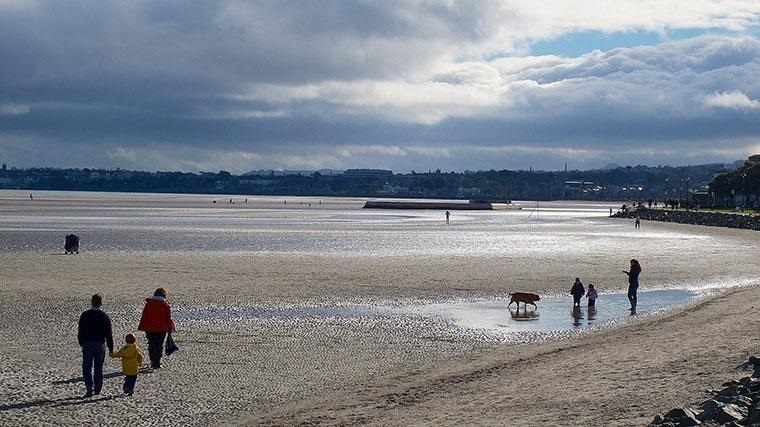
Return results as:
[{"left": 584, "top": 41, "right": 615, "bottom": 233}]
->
[{"left": 137, "top": 288, "right": 175, "bottom": 369}]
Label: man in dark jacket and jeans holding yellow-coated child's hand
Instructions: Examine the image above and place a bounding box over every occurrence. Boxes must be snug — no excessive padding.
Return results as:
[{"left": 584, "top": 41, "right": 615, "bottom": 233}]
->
[{"left": 77, "top": 294, "right": 113, "bottom": 397}]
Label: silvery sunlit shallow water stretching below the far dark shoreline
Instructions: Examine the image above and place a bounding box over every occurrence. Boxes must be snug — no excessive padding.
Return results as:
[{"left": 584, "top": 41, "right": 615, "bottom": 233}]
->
[{"left": 0, "top": 190, "right": 720, "bottom": 256}]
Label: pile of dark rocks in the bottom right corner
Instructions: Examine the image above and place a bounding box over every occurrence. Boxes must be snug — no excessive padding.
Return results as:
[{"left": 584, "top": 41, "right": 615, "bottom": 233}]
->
[{"left": 649, "top": 356, "right": 760, "bottom": 427}]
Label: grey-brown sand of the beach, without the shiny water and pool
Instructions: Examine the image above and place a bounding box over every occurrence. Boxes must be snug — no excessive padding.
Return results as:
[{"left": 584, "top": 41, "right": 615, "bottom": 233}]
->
[{"left": 0, "top": 219, "right": 760, "bottom": 426}]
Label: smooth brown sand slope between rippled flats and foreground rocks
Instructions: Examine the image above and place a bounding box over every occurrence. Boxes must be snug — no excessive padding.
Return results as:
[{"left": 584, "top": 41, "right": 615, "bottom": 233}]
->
[{"left": 255, "top": 283, "right": 760, "bottom": 426}]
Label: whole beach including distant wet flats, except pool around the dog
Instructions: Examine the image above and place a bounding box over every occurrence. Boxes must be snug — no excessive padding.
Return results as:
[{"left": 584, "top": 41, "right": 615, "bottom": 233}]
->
[{"left": 0, "top": 193, "right": 760, "bottom": 425}]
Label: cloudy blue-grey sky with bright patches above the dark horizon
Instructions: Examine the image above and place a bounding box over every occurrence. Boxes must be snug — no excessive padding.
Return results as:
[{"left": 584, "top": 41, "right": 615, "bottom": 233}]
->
[{"left": 0, "top": 0, "right": 760, "bottom": 174}]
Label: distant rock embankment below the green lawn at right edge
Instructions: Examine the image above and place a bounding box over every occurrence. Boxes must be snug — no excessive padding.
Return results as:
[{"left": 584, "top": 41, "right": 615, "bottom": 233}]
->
[{"left": 612, "top": 208, "right": 760, "bottom": 230}]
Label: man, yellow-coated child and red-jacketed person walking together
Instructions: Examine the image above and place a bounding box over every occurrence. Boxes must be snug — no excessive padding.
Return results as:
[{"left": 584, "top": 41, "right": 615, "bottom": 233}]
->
[{"left": 77, "top": 288, "right": 175, "bottom": 397}]
